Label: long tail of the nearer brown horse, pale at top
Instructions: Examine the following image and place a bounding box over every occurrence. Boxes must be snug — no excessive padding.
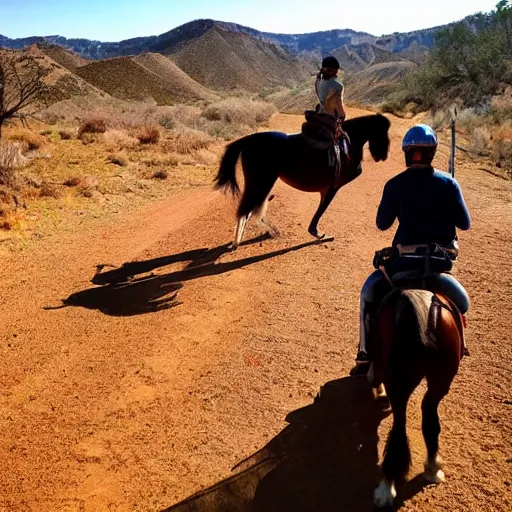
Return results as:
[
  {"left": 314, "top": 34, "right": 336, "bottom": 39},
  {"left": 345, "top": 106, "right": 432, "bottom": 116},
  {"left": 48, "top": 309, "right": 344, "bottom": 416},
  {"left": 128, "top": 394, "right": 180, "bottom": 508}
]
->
[{"left": 383, "top": 290, "right": 435, "bottom": 480}]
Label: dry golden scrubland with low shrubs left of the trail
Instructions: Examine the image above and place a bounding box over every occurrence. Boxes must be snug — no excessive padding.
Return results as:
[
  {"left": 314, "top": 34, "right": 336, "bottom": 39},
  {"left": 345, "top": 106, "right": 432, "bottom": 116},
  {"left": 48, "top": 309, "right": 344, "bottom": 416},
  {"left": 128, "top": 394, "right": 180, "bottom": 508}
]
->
[{"left": 0, "top": 92, "right": 275, "bottom": 241}]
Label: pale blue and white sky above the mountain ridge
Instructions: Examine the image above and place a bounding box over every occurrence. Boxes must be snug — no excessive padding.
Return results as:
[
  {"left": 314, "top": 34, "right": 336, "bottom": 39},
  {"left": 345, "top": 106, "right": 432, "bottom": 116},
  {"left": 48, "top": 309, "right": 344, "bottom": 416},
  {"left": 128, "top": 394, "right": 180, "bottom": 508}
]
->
[{"left": 0, "top": 0, "right": 498, "bottom": 41}]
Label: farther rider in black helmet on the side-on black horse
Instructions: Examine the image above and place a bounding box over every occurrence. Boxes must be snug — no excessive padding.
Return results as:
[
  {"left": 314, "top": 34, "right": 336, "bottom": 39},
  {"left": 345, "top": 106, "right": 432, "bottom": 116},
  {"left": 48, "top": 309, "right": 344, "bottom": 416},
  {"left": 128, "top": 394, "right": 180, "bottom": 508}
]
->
[{"left": 315, "top": 56, "right": 350, "bottom": 168}]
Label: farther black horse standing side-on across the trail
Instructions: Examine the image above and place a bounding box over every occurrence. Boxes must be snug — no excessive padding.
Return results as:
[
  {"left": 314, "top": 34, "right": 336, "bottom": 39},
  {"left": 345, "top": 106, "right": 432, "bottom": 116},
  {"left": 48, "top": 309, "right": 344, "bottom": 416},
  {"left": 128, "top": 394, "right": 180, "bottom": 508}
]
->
[{"left": 215, "top": 114, "right": 390, "bottom": 248}]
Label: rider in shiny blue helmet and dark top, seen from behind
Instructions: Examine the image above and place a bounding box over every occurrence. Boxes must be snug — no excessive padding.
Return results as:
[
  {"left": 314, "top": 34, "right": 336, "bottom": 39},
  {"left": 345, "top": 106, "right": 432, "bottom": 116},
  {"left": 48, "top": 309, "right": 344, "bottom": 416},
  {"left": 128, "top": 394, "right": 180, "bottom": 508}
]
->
[{"left": 351, "top": 124, "right": 471, "bottom": 375}]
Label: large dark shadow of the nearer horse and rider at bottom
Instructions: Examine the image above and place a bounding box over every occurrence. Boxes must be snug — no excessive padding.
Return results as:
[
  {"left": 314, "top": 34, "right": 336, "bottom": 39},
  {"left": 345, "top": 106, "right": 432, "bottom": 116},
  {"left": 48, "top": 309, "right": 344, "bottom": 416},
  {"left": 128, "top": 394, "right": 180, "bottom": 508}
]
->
[{"left": 164, "top": 377, "right": 389, "bottom": 512}]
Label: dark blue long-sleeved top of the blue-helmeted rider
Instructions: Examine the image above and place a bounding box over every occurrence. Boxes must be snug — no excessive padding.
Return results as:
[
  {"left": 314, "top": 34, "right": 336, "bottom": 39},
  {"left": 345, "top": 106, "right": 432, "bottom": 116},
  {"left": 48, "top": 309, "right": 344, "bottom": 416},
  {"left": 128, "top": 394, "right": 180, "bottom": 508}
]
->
[{"left": 377, "top": 167, "right": 471, "bottom": 245}]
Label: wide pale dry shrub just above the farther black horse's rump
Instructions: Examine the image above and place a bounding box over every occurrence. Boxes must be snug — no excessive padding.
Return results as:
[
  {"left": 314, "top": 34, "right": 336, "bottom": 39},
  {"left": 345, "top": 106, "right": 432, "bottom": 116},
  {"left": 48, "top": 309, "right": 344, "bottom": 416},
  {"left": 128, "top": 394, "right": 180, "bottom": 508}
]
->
[{"left": 201, "top": 98, "right": 276, "bottom": 127}]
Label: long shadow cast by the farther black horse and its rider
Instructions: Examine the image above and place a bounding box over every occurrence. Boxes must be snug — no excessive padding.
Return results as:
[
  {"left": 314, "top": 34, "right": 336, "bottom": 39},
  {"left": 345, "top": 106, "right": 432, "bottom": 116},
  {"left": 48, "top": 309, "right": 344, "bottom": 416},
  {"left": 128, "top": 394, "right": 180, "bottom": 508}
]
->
[{"left": 45, "top": 235, "right": 333, "bottom": 316}]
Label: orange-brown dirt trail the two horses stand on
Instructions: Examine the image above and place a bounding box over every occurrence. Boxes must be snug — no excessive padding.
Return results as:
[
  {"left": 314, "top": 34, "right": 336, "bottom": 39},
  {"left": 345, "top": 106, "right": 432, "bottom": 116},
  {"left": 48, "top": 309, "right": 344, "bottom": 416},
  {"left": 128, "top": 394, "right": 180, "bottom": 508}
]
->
[{"left": 0, "top": 110, "right": 512, "bottom": 512}]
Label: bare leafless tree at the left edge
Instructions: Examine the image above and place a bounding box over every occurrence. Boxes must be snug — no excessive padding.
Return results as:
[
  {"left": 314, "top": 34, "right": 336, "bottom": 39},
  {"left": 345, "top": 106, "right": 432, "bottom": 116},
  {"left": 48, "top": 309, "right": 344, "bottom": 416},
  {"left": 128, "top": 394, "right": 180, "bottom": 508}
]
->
[{"left": 0, "top": 50, "right": 49, "bottom": 139}]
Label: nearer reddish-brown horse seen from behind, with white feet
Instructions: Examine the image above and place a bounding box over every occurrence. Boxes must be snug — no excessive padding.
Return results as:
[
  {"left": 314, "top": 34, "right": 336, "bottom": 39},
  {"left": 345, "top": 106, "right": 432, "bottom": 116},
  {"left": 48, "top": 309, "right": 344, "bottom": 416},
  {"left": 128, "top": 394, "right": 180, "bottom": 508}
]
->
[{"left": 370, "top": 289, "right": 463, "bottom": 508}]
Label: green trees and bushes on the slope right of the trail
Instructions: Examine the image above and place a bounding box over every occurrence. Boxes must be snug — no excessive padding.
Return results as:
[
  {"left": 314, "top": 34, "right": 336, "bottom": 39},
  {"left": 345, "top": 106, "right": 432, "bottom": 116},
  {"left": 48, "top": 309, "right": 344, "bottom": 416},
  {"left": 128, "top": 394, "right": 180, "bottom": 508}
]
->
[{"left": 381, "top": 0, "right": 512, "bottom": 177}]
